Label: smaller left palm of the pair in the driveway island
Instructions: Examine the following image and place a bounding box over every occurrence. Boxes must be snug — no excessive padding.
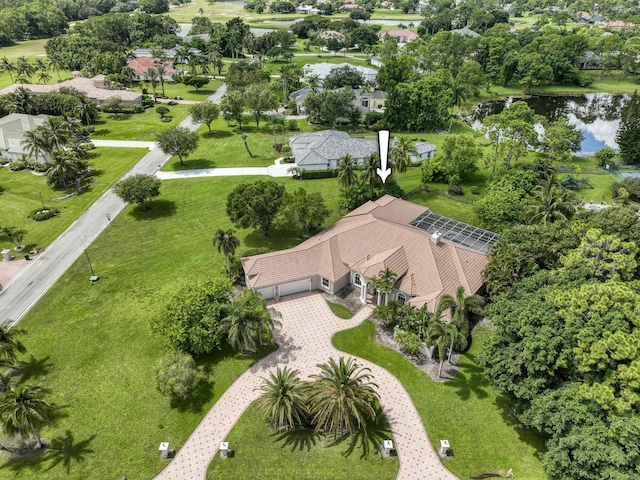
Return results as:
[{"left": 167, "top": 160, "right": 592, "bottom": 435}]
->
[{"left": 257, "top": 367, "right": 307, "bottom": 430}]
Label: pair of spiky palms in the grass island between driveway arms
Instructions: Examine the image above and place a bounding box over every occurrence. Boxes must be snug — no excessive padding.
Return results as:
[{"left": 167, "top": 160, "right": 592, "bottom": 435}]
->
[{"left": 257, "top": 357, "right": 379, "bottom": 437}]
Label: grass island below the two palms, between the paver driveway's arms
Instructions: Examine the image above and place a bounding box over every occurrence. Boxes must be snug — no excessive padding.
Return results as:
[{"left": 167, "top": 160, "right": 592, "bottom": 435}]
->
[{"left": 207, "top": 405, "right": 398, "bottom": 480}]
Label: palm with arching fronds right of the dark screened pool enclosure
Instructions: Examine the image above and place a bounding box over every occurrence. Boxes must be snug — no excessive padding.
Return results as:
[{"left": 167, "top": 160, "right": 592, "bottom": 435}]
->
[{"left": 528, "top": 176, "right": 575, "bottom": 224}]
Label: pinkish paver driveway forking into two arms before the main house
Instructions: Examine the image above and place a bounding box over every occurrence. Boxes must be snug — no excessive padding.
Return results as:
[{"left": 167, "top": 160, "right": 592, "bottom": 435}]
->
[{"left": 156, "top": 293, "right": 456, "bottom": 480}]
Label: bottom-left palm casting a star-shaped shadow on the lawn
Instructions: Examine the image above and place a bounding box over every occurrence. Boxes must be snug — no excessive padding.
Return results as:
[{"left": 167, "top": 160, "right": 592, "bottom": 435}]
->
[{"left": 0, "top": 385, "right": 56, "bottom": 448}]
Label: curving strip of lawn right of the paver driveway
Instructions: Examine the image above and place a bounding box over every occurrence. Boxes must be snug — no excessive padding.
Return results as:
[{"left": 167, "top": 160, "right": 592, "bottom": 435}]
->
[{"left": 333, "top": 321, "right": 546, "bottom": 480}]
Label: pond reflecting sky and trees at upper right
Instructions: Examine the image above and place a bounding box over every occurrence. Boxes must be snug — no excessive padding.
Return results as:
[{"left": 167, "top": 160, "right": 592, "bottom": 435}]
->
[{"left": 464, "top": 93, "right": 629, "bottom": 154}]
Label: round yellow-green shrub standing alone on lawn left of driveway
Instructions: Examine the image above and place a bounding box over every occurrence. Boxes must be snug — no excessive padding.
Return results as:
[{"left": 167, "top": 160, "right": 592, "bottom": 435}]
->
[{"left": 155, "top": 352, "right": 204, "bottom": 400}]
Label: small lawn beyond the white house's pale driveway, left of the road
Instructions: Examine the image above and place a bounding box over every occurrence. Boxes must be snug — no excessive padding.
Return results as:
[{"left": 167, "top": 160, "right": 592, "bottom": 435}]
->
[{"left": 91, "top": 105, "right": 189, "bottom": 142}]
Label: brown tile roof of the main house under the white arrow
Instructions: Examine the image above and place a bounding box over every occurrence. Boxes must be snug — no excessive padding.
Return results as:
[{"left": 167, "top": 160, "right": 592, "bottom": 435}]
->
[{"left": 242, "top": 196, "right": 488, "bottom": 310}]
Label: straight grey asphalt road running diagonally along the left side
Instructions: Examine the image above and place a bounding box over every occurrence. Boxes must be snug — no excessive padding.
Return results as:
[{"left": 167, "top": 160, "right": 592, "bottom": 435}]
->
[{"left": 0, "top": 115, "right": 200, "bottom": 325}]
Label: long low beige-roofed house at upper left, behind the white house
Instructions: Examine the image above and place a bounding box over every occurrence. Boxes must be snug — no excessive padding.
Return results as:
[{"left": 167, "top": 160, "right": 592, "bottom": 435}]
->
[{"left": 0, "top": 75, "right": 142, "bottom": 107}]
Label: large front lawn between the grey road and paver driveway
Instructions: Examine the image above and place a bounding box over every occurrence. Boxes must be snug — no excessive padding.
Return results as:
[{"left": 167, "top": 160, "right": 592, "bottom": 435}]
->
[{"left": 0, "top": 174, "right": 350, "bottom": 480}]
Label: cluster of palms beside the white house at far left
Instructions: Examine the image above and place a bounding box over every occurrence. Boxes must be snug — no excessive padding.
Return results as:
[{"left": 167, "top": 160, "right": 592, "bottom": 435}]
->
[{"left": 22, "top": 117, "right": 93, "bottom": 188}]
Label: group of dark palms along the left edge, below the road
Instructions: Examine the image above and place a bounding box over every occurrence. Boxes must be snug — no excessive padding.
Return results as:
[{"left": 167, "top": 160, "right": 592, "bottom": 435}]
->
[{"left": 0, "top": 325, "right": 56, "bottom": 449}]
